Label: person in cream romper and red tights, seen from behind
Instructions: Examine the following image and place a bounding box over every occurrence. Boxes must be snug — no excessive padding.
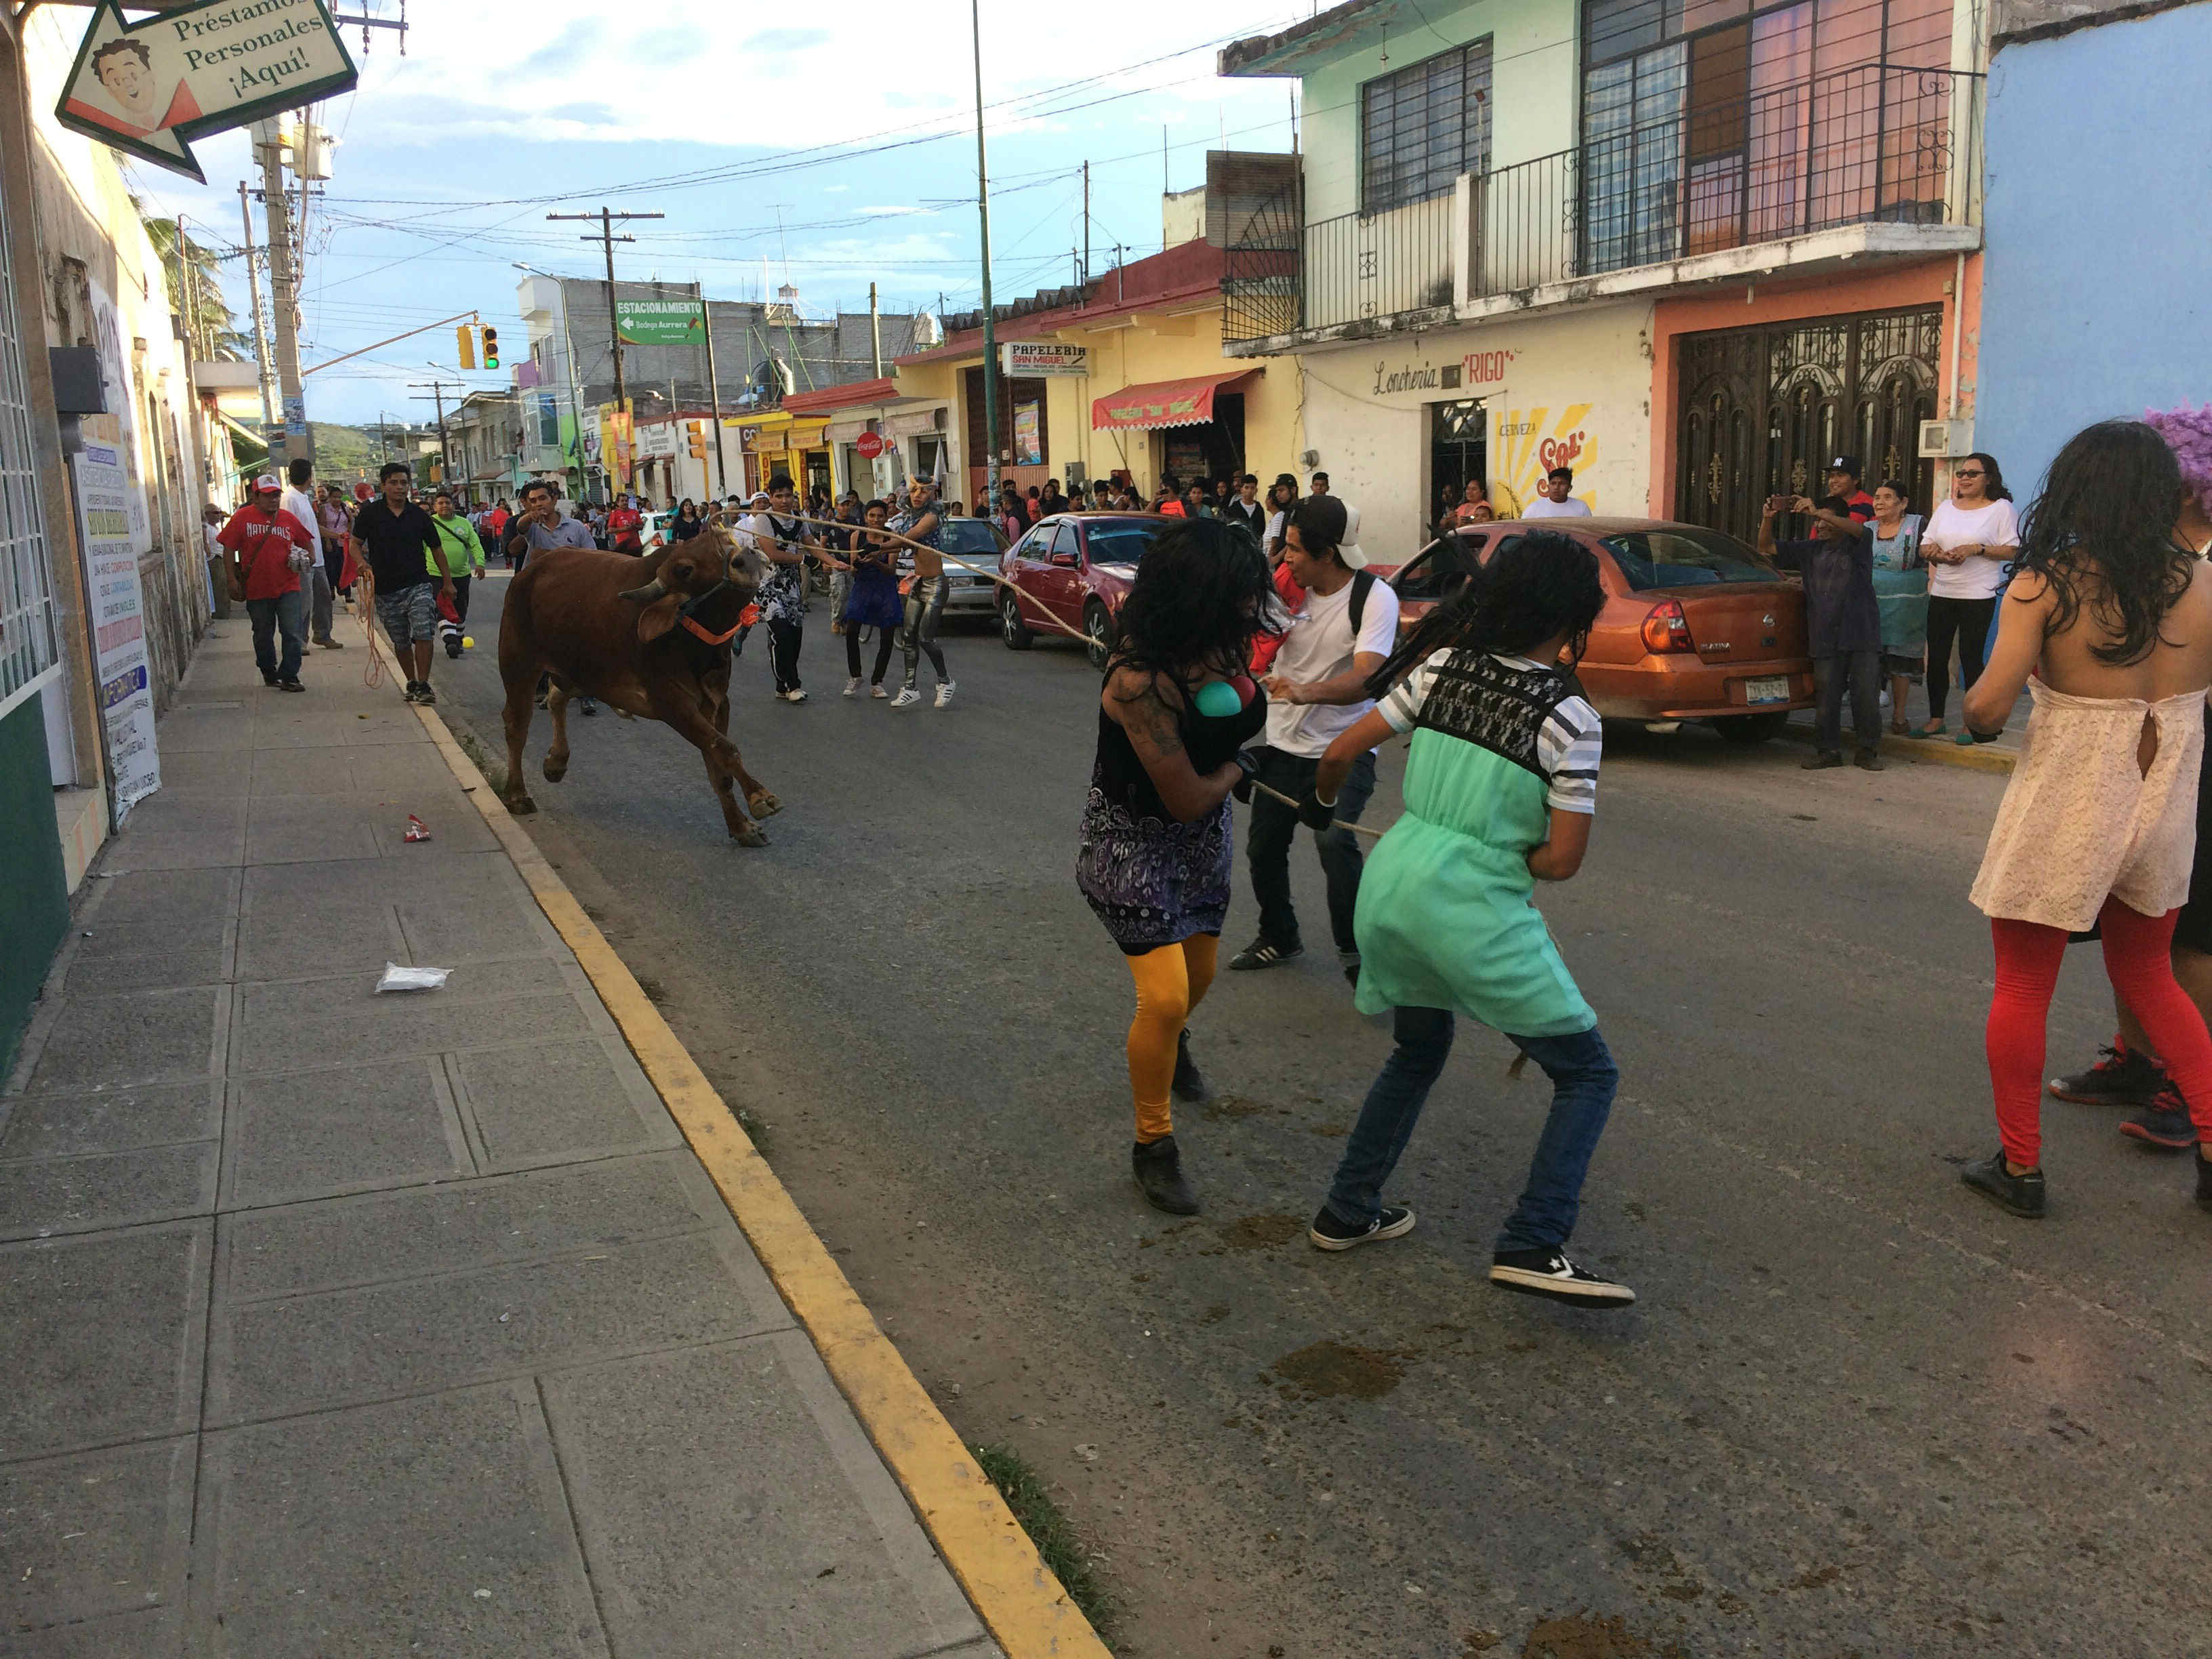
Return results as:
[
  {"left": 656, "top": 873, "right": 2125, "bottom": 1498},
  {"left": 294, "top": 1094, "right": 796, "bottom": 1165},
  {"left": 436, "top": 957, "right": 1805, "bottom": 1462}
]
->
[{"left": 1960, "top": 420, "right": 2212, "bottom": 1216}]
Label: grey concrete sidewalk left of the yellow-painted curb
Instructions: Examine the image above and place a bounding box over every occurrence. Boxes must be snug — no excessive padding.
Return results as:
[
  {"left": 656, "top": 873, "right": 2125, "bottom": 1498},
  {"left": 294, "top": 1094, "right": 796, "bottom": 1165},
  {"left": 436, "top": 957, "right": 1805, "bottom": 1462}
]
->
[{"left": 0, "top": 619, "right": 998, "bottom": 1659}]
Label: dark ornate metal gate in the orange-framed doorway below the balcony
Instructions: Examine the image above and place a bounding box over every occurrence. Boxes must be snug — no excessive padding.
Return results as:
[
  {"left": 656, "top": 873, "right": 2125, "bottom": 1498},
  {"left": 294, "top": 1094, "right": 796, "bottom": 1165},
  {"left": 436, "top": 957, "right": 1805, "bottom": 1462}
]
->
[{"left": 1675, "top": 308, "right": 1942, "bottom": 542}]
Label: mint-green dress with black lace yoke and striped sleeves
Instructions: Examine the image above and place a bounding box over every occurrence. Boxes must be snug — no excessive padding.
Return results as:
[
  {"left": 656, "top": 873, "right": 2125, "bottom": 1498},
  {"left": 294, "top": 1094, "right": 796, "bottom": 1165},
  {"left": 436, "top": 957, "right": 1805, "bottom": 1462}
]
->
[{"left": 1354, "top": 651, "right": 1599, "bottom": 1038}]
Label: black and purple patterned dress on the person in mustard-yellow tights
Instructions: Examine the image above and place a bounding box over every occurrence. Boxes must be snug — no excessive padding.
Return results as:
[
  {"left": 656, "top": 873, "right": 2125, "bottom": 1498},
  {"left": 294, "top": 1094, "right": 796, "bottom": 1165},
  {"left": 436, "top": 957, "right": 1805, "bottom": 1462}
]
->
[{"left": 1075, "top": 686, "right": 1267, "bottom": 956}]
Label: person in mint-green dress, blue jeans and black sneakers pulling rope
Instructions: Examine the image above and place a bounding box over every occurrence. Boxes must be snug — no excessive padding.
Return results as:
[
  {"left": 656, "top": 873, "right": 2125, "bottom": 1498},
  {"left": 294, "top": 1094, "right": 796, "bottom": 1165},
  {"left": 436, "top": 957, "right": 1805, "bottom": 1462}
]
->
[{"left": 1300, "top": 531, "right": 1635, "bottom": 1307}]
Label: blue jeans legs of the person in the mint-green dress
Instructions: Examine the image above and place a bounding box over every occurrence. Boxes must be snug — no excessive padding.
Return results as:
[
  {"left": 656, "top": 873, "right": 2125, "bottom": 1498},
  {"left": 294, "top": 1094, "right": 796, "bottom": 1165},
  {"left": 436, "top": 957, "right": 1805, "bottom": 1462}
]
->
[{"left": 1327, "top": 1008, "right": 1622, "bottom": 1250}]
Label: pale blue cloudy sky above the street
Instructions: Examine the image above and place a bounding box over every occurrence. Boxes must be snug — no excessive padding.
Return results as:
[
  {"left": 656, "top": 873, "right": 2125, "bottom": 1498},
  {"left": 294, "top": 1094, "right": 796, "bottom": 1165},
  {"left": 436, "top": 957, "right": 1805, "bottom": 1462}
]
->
[{"left": 133, "top": 0, "right": 1314, "bottom": 422}]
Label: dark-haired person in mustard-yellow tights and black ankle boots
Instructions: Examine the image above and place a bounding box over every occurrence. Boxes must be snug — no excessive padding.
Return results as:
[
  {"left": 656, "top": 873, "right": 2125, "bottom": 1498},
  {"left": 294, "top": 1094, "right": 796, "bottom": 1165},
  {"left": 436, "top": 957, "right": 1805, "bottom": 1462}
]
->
[{"left": 1075, "top": 518, "right": 1270, "bottom": 1214}]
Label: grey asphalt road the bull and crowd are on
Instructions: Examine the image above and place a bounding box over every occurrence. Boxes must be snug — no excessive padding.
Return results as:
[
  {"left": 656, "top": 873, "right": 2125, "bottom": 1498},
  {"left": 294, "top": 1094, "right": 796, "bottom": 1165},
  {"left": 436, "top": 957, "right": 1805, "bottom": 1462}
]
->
[{"left": 422, "top": 577, "right": 2212, "bottom": 1659}]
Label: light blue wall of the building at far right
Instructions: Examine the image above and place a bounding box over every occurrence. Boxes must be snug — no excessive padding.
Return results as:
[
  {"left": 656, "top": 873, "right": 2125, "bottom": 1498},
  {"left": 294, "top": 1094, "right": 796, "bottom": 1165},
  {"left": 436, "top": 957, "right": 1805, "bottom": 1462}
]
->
[{"left": 1973, "top": 5, "right": 2212, "bottom": 504}]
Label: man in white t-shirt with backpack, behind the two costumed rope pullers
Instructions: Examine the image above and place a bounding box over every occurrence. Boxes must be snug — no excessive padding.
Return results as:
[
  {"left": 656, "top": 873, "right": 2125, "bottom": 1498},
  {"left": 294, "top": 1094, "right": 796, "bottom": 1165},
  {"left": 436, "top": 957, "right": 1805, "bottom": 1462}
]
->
[{"left": 1230, "top": 495, "right": 1398, "bottom": 982}]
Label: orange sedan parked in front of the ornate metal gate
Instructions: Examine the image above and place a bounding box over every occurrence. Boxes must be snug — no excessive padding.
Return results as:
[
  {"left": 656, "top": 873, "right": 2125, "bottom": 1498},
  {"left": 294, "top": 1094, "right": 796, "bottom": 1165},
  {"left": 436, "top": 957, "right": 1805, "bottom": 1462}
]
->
[{"left": 1389, "top": 518, "right": 1811, "bottom": 743}]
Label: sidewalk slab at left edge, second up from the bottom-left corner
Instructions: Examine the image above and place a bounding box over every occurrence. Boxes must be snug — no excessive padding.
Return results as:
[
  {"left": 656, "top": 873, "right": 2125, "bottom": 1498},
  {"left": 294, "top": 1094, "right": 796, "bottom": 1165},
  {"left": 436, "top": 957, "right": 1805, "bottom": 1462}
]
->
[{"left": 0, "top": 1221, "right": 212, "bottom": 1460}]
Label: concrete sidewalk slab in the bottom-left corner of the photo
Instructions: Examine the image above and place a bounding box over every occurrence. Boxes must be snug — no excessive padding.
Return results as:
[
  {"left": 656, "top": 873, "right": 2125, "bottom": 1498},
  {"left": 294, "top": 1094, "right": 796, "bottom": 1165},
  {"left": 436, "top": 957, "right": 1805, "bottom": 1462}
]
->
[{"left": 0, "top": 1435, "right": 194, "bottom": 1652}]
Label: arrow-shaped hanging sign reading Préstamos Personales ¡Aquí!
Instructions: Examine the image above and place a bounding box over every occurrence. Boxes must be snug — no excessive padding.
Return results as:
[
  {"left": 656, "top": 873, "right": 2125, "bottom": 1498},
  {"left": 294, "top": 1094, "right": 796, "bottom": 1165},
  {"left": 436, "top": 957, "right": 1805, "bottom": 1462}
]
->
[{"left": 53, "top": 0, "right": 359, "bottom": 184}]
